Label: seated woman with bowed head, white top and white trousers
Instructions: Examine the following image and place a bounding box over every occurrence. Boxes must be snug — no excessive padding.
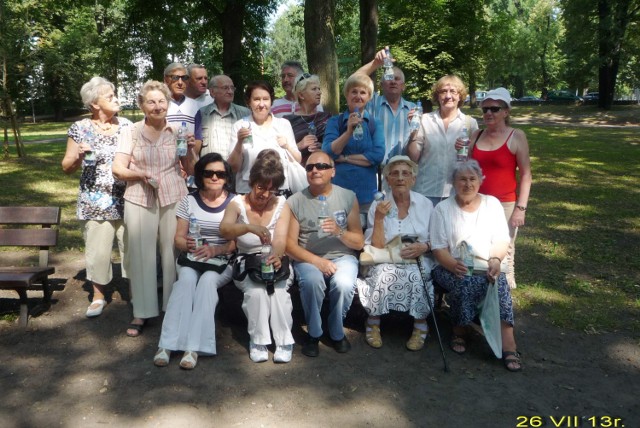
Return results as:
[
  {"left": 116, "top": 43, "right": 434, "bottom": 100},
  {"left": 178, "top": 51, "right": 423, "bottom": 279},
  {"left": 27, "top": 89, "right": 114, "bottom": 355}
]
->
[{"left": 220, "top": 150, "right": 294, "bottom": 363}]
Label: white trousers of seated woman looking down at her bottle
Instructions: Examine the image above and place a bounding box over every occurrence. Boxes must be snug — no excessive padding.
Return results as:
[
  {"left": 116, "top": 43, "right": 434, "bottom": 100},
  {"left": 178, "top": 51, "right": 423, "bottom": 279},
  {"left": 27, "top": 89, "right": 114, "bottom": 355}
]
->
[{"left": 234, "top": 275, "right": 295, "bottom": 346}]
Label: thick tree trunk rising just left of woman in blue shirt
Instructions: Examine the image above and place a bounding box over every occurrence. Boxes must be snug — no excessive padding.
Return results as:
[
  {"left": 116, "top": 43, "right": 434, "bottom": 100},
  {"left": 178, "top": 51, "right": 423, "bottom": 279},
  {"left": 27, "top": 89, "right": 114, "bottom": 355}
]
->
[{"left": 304, "top": 0, "right": 340, "bottom": 112}]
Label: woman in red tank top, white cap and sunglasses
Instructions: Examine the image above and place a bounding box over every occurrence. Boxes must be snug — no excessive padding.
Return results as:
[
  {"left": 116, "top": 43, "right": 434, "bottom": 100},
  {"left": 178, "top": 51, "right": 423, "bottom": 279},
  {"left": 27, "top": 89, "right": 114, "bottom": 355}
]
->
[{"left": 469, "top": 88, "right": 532, "bottom": 288}]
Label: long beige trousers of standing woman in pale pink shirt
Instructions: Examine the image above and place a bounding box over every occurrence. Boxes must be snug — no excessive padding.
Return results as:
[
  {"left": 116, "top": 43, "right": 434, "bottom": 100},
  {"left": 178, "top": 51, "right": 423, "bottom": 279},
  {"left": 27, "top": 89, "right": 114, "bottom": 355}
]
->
[{"left": 124, "top": 199, "right": 178, "bottom": 319}]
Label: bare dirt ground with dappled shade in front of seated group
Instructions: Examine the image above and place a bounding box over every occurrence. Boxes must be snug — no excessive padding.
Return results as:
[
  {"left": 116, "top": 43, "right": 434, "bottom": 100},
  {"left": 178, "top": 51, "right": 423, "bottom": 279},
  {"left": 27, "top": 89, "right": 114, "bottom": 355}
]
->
[{"left": 0, "top": 252, "right": 640, "bottom": 428}]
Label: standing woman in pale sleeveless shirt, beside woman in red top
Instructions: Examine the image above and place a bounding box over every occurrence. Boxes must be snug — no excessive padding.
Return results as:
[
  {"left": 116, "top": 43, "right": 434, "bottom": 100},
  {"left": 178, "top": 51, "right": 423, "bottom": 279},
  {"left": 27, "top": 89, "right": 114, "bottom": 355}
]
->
[{"left": 407, "top": 75, "right": 478, "bottom": 206}]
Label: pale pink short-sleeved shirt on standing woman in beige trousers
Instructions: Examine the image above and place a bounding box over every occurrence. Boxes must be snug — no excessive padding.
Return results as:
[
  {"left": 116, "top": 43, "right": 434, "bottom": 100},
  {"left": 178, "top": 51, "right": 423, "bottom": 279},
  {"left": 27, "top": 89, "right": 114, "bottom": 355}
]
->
[{"left": 116, "top": 120, "right": 187, "bottom": 208}]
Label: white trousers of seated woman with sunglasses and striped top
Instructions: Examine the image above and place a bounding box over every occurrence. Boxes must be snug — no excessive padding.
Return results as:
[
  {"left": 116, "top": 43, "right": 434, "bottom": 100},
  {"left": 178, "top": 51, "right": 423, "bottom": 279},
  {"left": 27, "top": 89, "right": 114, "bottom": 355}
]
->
[{"left": 158, "top": 266, "right": 231, "bottom": 355}]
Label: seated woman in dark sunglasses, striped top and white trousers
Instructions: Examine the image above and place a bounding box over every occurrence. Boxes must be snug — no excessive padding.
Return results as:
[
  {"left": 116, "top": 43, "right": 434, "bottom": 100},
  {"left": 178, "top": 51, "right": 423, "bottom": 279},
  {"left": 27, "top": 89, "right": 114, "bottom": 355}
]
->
[{"left": 153, "top": 153, "right": 235, "bottom": 370}]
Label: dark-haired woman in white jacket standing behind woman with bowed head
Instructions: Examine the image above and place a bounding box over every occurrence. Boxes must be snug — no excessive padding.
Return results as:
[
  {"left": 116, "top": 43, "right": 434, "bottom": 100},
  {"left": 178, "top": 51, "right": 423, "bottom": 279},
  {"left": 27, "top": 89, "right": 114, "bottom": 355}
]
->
[{"left": 227, "top": 80, "right": 302, "bottom": 194}]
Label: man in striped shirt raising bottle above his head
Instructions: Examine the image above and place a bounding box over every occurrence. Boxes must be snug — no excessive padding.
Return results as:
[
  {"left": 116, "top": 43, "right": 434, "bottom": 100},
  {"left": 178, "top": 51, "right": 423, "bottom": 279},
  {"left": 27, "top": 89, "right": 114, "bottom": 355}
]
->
[{"left": 358, "top": 49, "right": 416, "bottom": 166}]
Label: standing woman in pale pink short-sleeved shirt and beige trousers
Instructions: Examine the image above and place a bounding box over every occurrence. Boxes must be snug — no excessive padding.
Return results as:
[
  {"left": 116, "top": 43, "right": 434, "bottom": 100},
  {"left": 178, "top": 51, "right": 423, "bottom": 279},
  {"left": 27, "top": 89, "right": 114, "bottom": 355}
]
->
[{"left": 112, "top": 80, "right": 197, "bottom": 337}]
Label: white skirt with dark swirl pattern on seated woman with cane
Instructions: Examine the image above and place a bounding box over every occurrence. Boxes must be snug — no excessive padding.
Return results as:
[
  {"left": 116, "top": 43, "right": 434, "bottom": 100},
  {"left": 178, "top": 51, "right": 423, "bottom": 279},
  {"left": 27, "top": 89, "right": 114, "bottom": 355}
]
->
[{"left": 357, "top": 263, "right": 433, "bottom": 319}]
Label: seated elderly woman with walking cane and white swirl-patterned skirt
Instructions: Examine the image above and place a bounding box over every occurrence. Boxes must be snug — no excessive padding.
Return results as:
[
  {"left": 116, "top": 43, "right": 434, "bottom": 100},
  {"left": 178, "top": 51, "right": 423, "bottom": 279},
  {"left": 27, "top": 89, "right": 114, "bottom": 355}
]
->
[{"left": 357, "top": 156, "right": 433, "bottom": 351}]
